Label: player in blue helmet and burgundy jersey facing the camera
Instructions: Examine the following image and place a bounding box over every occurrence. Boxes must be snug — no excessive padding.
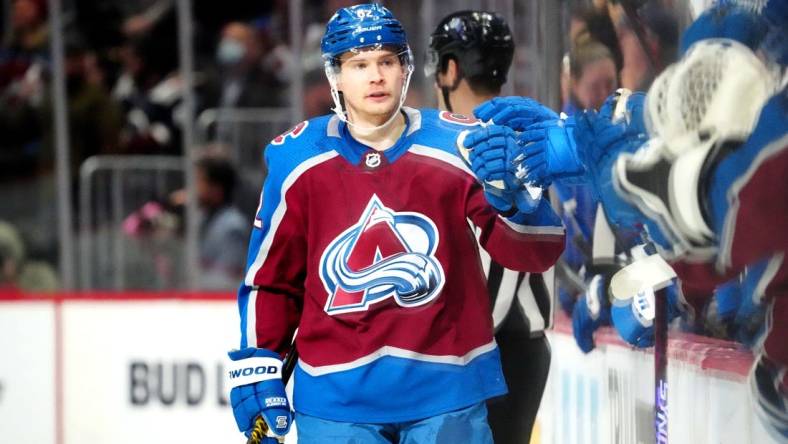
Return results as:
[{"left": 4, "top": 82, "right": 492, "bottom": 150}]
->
[{"left": 229, "top": 4, "right": 564, "bottom": 444}]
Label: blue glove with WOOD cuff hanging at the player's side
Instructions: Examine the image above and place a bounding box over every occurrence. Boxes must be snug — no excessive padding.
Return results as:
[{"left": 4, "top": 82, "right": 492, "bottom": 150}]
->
[{"left": 228, "top": 347, "right": 293, "bottom": 444}]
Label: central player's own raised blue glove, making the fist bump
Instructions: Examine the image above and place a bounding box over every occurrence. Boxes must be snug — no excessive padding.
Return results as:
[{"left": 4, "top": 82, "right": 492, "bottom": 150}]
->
[{"left": 461, "top": 125, "right": 541, "bottom": 216}]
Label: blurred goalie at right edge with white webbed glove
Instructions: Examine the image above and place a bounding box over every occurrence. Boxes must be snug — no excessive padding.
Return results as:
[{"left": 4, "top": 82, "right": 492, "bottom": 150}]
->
[{"left": 516, "top": 39, "right": 788, "bottom": 439}]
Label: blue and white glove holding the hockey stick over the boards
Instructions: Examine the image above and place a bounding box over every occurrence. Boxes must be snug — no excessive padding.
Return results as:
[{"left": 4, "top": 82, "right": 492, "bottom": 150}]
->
[{"left": 610, "top": 284, "right": 682, "bottom": 348}]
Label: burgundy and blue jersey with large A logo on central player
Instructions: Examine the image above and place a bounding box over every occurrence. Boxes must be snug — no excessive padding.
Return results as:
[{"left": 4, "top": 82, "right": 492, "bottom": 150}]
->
[{"left": 239, "top": 108, "right": 564, "bottom": 423}]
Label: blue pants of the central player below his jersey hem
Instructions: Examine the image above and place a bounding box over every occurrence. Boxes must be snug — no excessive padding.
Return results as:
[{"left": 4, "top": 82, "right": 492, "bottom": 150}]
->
[{"left": 295, "top": 402, "right": 493, "bottom": 444}]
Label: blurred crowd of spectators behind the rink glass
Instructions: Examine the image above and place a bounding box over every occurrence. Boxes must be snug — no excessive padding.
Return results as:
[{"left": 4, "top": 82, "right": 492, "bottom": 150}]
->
[{"left": 0, "top": 0, "right": 720, "bottom": 336}]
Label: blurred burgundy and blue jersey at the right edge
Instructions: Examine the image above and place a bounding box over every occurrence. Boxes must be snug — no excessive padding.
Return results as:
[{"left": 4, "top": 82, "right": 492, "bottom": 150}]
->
[{"left": 671, "top": 88, "right": 788, "bottom": 400}]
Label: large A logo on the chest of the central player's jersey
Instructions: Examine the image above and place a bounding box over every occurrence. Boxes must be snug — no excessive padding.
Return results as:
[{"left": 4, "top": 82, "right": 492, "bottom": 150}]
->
[{"left": 320, "top": 195, "right": 445, "bottom": 315}]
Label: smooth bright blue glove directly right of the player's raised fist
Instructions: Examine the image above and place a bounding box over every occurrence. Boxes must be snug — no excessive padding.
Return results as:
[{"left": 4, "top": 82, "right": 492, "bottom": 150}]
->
[{"left": 517, "top": 118, "right": 586, "bottom": 186}]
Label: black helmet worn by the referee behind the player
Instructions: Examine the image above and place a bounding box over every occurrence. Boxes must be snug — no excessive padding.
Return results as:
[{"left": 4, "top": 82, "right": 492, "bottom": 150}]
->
[{"left": 424, "top": 11, "right": 514, "bottom": 85}]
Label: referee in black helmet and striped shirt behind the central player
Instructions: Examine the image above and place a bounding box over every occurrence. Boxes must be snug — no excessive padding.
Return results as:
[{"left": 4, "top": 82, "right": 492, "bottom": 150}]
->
[{"left": 424, "top": 11, "right": 557, "bottom": 444}]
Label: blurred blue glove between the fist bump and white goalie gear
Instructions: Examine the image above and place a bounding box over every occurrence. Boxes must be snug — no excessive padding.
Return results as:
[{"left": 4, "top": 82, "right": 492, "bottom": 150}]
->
[{"left": 574, "top": 110, "right": 645, "bottom": 230}]
